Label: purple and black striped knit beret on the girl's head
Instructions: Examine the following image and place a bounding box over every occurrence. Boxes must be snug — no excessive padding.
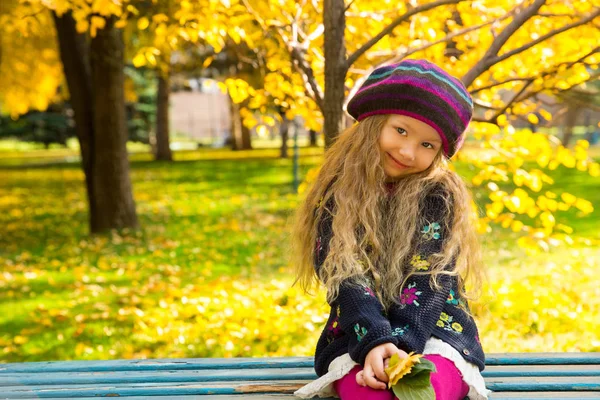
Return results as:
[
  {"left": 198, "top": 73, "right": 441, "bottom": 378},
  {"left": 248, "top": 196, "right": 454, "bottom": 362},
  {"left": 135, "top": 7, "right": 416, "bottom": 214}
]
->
[{"left": 348, "top": 60, "right": 473, "bottom": 158}]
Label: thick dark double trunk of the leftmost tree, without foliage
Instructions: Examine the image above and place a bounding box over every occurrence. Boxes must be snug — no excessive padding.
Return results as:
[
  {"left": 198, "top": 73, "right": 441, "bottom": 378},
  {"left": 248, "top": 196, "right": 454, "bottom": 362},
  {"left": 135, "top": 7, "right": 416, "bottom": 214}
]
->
[{"left": 53, "top": 12, "right": 138, "bottom": 232}]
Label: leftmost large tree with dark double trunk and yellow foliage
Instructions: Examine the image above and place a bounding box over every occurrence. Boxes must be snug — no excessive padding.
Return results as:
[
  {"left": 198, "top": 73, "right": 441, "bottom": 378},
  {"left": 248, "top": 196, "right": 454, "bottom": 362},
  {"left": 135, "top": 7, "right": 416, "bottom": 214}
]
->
[{"left": 2, "top": 2, "right": 138, "bottom": 232}]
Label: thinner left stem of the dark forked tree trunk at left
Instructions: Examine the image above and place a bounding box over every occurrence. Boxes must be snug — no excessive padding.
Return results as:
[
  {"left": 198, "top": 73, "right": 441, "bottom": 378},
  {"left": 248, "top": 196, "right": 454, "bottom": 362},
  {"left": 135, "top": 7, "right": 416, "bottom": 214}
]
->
[{"left": 52, "top": 12, "right": 99, "bottom": 232}]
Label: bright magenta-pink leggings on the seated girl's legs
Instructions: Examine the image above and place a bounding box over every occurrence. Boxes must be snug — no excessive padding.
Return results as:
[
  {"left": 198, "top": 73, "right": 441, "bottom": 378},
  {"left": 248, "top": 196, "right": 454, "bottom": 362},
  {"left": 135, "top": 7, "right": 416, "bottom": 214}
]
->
[{"left": 333, "top": 354, "right": 469, "bottom": 400}]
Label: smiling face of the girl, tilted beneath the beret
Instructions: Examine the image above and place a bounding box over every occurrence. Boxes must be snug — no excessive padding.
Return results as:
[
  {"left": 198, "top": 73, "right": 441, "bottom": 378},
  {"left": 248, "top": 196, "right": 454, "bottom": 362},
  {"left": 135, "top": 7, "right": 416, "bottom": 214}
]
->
[{"left": 379, "top": 114, "right": 442, "bottom": 180}]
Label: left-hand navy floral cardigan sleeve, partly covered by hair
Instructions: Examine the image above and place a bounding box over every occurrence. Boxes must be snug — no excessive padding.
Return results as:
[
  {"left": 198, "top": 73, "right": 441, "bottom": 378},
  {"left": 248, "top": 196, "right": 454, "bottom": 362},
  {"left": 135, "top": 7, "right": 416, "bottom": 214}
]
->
[{"left": 315, "top": 198, "right": 398, "bottom": 365}]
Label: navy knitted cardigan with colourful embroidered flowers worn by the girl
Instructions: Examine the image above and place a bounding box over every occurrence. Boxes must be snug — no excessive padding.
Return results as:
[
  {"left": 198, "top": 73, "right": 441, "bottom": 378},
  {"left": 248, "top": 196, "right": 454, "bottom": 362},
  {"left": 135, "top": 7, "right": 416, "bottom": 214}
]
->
[{"left": 314, "top": 186, "right": 485, "bottom": 376}]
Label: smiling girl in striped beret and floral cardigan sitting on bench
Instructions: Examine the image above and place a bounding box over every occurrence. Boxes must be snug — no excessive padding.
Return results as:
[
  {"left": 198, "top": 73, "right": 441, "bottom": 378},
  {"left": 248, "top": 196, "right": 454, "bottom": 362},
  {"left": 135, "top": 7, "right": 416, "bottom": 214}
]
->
[{"left": 294, "top": 60, "right": 489, "bottom": 400}]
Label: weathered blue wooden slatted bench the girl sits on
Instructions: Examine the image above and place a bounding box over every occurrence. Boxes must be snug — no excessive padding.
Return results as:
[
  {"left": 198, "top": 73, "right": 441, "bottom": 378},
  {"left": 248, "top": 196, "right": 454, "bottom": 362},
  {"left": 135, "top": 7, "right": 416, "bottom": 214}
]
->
[{"left": 0, "top": 353, "right": 600, "bottom": 400}]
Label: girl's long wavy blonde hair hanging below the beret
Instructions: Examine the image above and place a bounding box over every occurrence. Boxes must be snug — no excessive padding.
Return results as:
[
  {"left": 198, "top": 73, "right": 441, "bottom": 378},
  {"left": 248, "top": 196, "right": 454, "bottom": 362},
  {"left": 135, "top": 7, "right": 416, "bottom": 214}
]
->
[{"left": 292, "top": 115, "right": 483, "bottom": 308}]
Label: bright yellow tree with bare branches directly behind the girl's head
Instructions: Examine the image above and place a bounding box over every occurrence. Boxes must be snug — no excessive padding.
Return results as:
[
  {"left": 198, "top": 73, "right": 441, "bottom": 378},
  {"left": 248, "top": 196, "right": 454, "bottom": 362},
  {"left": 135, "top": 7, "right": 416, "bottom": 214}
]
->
[{"left": 234, "top": 0, "right": 600, "bottom": 247}]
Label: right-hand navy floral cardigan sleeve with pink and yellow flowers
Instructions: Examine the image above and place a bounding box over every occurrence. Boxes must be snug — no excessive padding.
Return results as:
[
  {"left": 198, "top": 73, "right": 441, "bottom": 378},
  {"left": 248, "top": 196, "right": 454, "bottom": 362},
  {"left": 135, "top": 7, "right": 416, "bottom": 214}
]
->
[{"left": 390, "top": 190, "right": 457, "bottom": 353}]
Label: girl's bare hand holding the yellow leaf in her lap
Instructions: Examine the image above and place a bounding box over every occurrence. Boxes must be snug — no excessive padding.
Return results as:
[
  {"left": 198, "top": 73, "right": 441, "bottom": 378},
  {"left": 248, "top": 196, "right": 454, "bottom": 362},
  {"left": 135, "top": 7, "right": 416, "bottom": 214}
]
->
[{"left": 356, "top": 343, "right": 408, "bottom": 390}]
